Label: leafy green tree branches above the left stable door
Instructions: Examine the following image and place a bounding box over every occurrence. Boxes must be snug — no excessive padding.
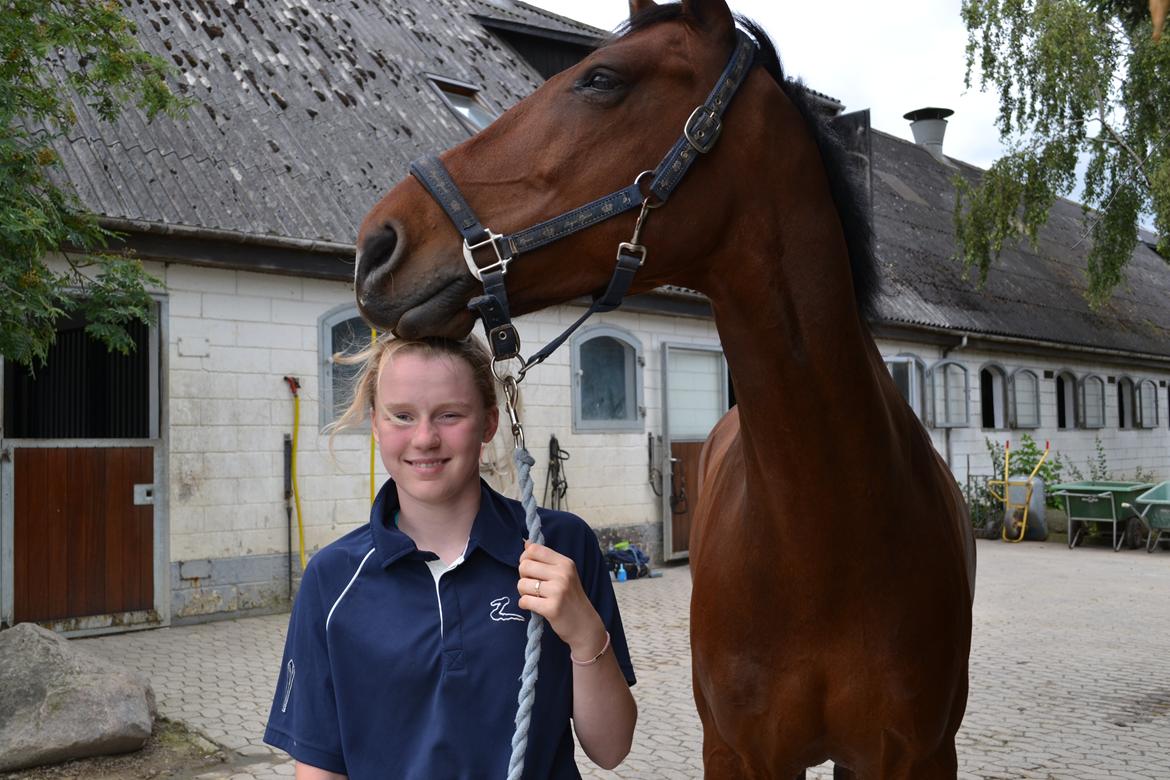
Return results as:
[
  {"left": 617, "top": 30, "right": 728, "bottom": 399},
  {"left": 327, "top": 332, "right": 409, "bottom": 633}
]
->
[{"left": 0, "top": 0, "right": 185, "bottom": 366}]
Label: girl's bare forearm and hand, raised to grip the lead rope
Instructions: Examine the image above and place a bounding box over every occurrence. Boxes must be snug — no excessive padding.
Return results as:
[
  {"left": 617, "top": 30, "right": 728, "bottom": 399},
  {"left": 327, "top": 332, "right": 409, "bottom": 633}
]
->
[{"left": 517, "top": 543, "right": 638, "bottom": 769}]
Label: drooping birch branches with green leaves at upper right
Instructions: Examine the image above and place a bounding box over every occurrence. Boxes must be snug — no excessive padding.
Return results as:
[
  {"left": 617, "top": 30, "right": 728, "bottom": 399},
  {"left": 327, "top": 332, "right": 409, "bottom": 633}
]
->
[{"left": 955, "top": 0, "right": 1170, "bottom": 306}]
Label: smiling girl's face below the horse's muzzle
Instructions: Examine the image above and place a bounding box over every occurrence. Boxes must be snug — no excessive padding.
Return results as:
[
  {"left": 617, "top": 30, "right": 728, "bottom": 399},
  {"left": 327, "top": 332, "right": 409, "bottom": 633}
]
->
[{"left": 373, "top": 353, "right": 500, "bottom": 508}]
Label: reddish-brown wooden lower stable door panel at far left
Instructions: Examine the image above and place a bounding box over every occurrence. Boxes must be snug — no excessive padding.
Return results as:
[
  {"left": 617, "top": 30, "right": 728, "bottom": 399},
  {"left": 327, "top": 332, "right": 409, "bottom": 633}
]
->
[{"left": 13, "top": 447, "right": 154, "bottom": 622}]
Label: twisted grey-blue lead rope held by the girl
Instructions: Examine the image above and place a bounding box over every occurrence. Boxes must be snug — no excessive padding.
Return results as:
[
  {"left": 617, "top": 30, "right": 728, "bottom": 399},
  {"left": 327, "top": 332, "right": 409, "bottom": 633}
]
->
[{"left": 491, "top": 371, "right": 544, "bottom": 780}]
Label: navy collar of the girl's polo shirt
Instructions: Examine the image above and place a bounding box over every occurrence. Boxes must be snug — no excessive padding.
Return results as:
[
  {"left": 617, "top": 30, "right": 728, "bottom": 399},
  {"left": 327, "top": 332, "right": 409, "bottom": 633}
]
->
[{"left": 370, "top": 479, "right": 527, "bottom": 567}]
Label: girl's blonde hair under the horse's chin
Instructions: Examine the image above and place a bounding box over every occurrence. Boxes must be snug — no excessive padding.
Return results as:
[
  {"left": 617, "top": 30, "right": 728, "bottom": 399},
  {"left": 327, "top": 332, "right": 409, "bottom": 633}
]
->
[{"left": 329, "top": 336, "right": 497, "bottom": 437}]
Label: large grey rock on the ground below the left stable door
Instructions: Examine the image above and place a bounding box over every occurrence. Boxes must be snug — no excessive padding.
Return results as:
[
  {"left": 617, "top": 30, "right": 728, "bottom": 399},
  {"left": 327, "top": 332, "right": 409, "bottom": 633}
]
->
[{"left": 0, "top": 623, "right": 156, "bottom": 772}]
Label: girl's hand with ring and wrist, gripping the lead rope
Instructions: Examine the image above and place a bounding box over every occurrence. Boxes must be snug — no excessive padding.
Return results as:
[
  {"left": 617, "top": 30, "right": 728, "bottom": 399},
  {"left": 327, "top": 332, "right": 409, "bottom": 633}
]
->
[{"left": 516, "top": 541, "right": 605, "bottom": 661}]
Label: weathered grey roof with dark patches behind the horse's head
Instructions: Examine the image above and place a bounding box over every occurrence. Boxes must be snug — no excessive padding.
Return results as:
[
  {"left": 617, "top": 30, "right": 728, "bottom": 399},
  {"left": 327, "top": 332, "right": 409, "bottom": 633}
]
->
[{"left": 47, "top": 0, "right": 549, "bottom": 243}]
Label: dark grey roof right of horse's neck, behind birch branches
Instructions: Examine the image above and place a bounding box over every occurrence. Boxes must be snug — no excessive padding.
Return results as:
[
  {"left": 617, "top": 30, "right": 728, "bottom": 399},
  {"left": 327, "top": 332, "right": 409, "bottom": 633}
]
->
[{"left": 872, "top": 131, "right": 1170, "bottom": 357}]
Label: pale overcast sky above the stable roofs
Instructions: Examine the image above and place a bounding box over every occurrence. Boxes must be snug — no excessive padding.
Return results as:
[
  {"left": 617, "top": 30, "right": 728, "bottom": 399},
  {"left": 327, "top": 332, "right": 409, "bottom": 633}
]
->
[{"left": 528, "top": 0, "right": 1000, "bottom": 168}]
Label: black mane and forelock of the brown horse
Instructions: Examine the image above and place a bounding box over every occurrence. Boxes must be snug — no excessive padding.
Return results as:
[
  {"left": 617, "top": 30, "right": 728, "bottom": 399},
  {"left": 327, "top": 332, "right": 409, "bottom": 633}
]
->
[{"left": 615, "top": 4, "right": 881, "bottom": 319}]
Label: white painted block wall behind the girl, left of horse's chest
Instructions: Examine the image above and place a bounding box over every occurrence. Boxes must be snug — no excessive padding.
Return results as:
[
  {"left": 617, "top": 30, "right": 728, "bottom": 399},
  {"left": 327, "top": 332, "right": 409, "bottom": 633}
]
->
[{"left": 156, "top": 264, "right": 717, "bottom": 560}]
